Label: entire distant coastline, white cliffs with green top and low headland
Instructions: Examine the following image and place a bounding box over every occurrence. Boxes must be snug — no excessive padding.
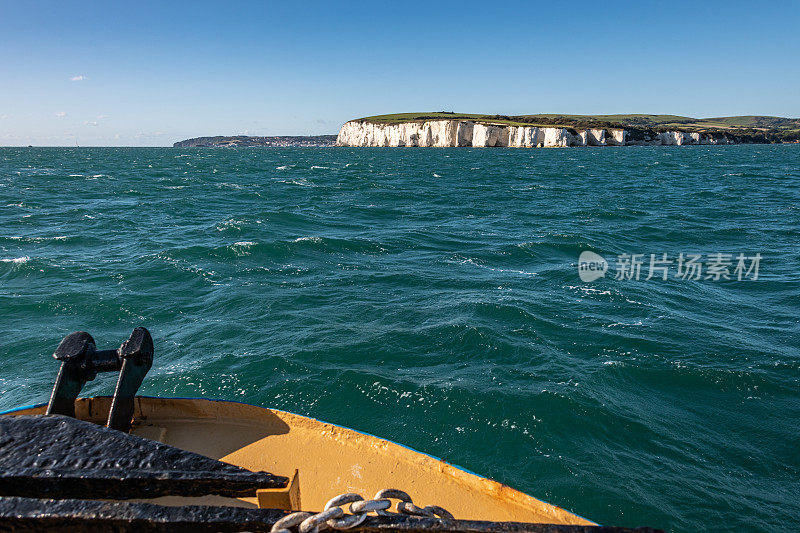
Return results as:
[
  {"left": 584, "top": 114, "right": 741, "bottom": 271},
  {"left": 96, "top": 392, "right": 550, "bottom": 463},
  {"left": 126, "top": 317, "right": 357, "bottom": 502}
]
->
[{"left": 173, "top": 111, "right": 800, "bottom": 148}]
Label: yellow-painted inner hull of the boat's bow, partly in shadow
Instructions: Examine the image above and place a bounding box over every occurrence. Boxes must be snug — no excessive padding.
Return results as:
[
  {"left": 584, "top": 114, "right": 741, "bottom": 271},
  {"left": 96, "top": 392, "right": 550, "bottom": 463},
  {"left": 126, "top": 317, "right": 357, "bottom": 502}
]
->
[{"left": 7, "top": 397, "right": 593, "bottom": 525}]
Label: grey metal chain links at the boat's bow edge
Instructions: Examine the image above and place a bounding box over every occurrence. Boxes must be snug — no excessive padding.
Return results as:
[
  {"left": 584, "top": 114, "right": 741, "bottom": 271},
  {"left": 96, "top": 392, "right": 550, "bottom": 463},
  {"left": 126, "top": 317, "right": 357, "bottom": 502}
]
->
[{"left": 271, "top": 489, "right": 453, "bottom": 533}]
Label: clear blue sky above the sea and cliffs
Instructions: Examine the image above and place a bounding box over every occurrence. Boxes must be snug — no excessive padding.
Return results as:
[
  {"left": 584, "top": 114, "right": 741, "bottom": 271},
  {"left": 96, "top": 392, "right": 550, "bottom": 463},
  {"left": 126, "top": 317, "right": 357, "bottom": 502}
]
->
[{"left": 0, "top": 0, "right": 800, "bottom": 146}]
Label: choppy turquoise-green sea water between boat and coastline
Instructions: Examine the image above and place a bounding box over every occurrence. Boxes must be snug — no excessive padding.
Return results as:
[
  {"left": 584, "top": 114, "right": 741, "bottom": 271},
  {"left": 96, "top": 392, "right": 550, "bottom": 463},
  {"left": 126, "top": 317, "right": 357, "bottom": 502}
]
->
[{"left": 0, "top": 146, "right": 800, "bottom": 531}]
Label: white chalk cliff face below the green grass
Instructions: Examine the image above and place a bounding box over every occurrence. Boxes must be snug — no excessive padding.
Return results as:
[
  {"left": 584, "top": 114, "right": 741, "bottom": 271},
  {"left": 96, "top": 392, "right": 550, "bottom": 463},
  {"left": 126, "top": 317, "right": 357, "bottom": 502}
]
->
[{"left": 336, "top": 120, "right": 732, "bottom": 148}]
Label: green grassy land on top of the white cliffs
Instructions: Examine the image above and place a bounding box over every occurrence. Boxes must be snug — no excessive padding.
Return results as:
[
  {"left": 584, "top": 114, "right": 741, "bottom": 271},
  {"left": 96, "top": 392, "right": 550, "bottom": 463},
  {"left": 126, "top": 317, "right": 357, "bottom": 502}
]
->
[{"left": 357, "top": 111, "right": 800, "bottom": 131}]
